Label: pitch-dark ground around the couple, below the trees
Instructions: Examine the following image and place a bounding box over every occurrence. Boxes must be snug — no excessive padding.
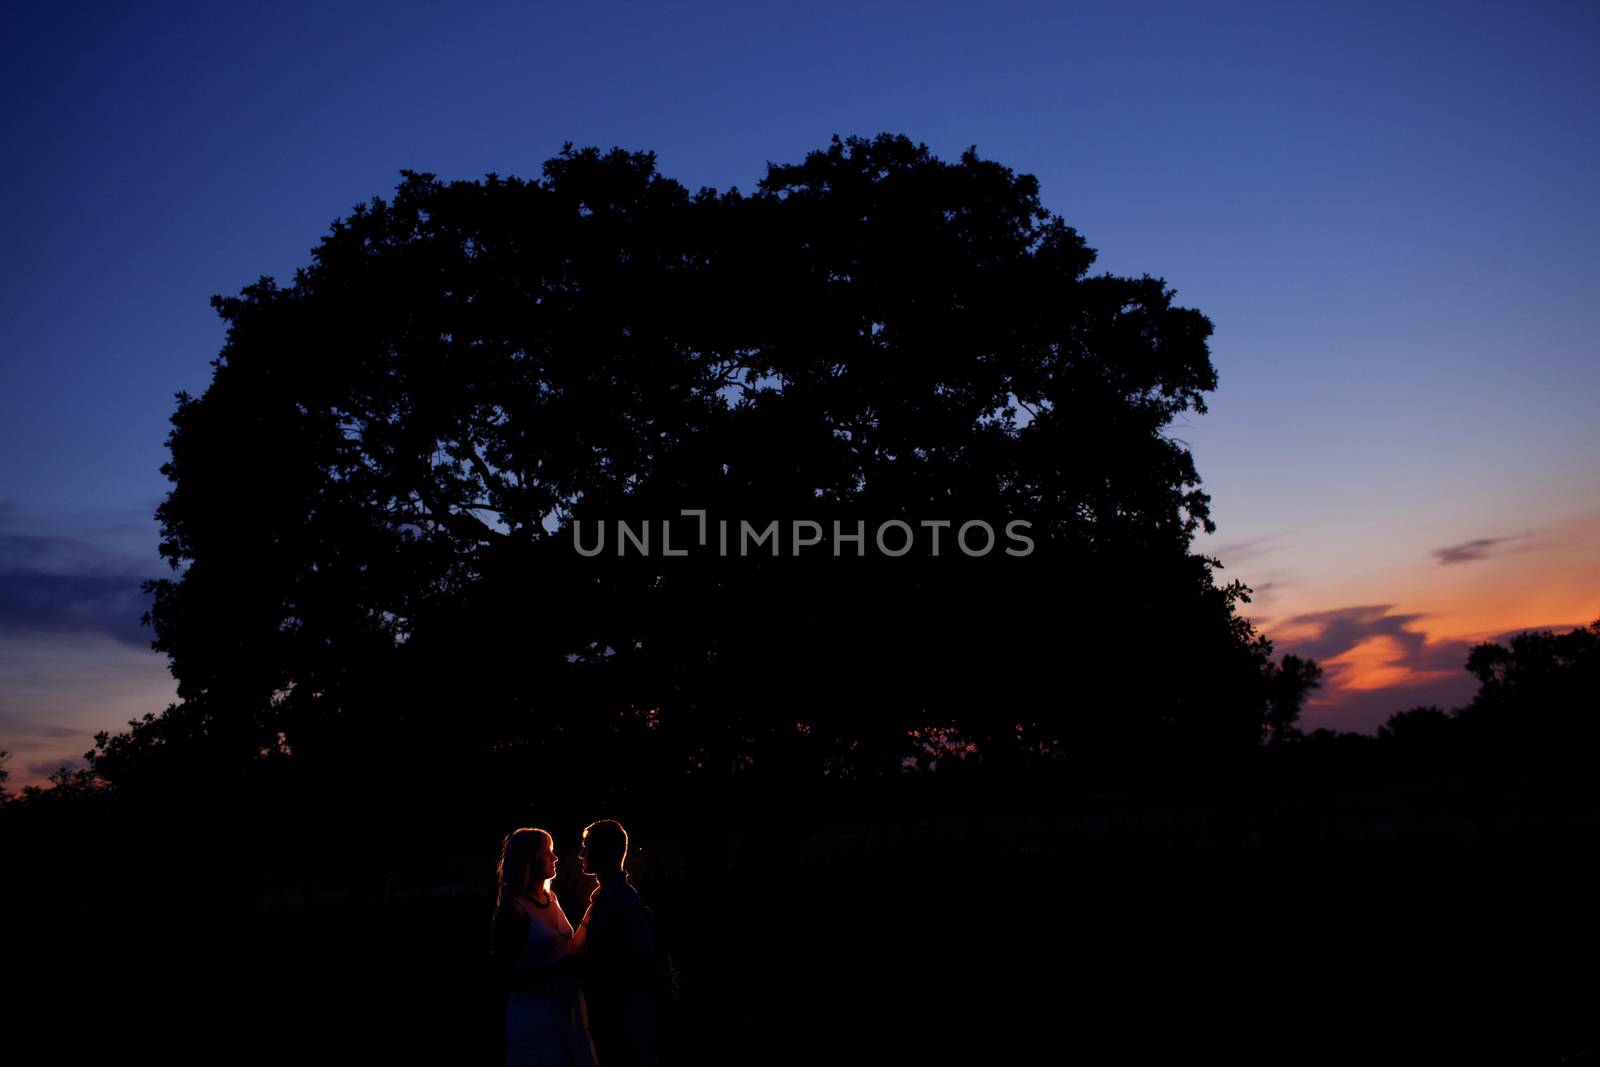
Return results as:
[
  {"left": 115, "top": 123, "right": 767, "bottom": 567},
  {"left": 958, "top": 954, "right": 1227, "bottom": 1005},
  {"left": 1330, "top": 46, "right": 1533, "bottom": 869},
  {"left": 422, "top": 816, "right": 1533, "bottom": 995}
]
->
[{"left": 8, "top": 774, "right": 1600, "bottom": 1064}]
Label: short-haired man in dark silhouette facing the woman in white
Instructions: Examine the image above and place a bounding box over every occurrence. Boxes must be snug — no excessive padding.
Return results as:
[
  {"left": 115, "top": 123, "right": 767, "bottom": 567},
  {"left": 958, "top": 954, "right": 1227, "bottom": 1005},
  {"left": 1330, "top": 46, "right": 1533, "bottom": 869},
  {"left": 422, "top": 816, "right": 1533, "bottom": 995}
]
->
[{"left": 573, "top": 819, "right": 656, "bottom": 1067}]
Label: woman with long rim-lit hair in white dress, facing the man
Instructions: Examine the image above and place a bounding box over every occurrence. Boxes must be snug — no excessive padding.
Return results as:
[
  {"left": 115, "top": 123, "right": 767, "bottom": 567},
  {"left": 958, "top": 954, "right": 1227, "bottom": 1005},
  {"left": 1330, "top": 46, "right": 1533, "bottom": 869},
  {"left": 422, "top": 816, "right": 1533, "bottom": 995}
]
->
[{"left": 491, "top": 827, "right": 594, "bottom": 1067}]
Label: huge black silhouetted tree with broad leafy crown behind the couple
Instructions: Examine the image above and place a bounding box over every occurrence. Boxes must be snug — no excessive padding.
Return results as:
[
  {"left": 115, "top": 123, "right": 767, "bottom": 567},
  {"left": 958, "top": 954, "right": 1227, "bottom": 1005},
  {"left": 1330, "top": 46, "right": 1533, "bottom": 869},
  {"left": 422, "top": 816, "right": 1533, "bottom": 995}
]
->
[{"left": 96, "top": 136, "right": 1282, "bottom": 799}]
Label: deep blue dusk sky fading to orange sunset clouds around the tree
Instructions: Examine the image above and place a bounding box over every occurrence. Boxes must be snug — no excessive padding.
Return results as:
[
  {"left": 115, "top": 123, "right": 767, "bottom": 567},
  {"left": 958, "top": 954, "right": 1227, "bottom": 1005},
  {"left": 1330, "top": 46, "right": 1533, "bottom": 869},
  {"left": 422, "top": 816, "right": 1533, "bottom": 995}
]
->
[{"left": 0, "top": 0, "right": 1600, "bottom": 785}]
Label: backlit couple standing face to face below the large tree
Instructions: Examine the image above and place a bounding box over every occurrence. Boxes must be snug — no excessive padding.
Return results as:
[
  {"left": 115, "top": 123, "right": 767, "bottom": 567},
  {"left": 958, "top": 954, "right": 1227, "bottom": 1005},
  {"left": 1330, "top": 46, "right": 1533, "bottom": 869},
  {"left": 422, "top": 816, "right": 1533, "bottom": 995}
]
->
[{"left": 491, "top": 819, "right": 658, "bottom": 1067}]
